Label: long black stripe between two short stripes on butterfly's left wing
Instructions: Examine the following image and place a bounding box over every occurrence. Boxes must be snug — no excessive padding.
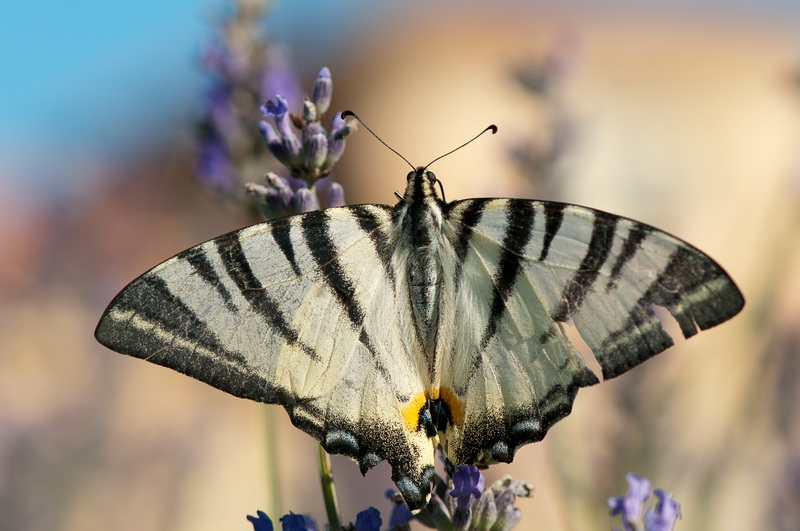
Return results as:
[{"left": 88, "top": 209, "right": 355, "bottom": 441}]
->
[{"left": 215, "top": 232, "right": 320, "bottom": 360}]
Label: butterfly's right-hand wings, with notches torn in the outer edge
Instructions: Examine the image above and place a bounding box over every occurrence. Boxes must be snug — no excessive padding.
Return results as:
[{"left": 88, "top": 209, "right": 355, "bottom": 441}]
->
[{"left": 441, "top": 199, "right": 744, "bottom": 470}]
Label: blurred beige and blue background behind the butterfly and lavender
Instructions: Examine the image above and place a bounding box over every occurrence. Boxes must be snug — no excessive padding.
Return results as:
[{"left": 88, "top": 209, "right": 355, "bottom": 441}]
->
[{"left": 0, "top": 0, "right": 800, "bottom": 530}]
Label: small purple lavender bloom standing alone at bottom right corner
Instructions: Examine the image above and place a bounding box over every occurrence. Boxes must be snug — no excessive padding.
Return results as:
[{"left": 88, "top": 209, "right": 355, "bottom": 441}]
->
[{"left": 608, "top": 474, "right": 681, "bottom": 531}]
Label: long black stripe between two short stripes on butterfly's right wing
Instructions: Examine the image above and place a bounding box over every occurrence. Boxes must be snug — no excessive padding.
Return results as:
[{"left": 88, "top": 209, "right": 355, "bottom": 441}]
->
[{"left": 552, "top": 212, "right": 617, "bottom": 322}]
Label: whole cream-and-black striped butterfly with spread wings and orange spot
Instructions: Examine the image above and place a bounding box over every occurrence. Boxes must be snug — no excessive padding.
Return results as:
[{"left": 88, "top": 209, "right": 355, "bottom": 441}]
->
[{"left": 96, "top": 113, "right": 744, "bottom": 510}]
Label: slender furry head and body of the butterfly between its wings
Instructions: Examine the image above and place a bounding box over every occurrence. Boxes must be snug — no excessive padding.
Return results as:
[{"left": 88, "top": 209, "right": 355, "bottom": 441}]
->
[{"left": 394, "top": 168, "right": 444, "bottom": 363}]
